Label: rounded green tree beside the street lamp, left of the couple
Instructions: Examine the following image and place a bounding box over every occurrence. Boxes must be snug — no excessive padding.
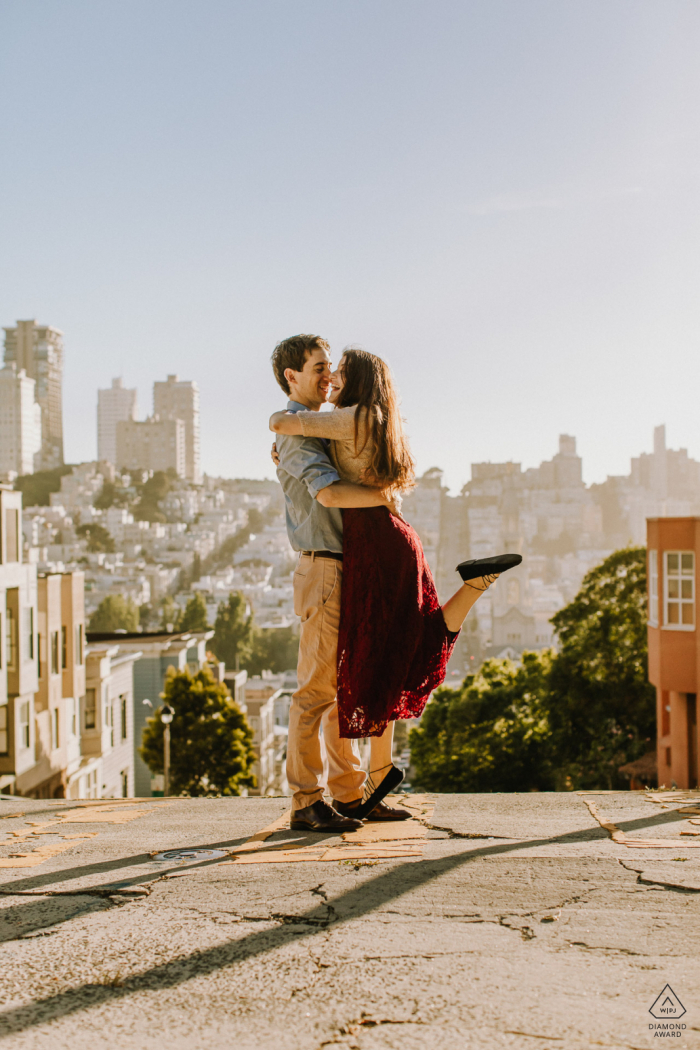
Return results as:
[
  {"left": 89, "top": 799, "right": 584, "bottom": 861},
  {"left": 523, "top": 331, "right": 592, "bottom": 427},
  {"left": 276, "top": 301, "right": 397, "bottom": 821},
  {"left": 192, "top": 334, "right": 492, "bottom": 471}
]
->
[{"left": 140, "top": 668, "right": 255, "bottom": 797}]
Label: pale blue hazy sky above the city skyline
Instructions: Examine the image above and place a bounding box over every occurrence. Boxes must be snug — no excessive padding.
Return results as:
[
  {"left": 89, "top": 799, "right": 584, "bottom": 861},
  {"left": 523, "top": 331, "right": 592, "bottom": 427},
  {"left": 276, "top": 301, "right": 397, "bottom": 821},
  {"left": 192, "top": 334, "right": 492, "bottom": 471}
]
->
[{"left": 0, "top": 0, "right": 700, "bottom": 491}]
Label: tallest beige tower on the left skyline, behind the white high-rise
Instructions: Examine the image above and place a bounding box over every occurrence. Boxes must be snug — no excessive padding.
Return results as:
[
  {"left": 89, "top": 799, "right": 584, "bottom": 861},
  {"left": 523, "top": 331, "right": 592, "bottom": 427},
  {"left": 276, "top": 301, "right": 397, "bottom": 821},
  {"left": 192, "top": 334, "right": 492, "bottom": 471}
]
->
[{"left": 4, "top": 320, "right": 63, "bottom": 470}]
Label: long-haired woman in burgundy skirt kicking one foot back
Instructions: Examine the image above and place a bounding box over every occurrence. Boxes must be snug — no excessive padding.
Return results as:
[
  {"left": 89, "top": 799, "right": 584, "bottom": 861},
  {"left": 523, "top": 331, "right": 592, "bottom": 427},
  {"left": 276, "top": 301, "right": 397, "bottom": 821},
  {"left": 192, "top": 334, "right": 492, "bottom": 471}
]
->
[{"left": 270, "top": 348, "right": 522, "bottom": 817}]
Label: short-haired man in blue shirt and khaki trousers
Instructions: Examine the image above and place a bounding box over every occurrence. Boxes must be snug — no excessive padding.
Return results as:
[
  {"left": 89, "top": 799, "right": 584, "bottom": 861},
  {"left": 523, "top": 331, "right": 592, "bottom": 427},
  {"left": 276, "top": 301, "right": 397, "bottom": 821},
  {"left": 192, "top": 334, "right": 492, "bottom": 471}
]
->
[{"left": 272, "top": 335, "right": 394, "bottom": 832}]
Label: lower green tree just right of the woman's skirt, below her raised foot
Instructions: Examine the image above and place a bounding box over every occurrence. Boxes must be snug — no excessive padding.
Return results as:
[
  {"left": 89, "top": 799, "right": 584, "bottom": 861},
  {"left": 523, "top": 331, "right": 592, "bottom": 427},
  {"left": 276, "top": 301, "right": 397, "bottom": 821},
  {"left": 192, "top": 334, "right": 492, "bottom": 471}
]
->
[{"left": 409, "top": 651, "right": 553, "bottom": 792}]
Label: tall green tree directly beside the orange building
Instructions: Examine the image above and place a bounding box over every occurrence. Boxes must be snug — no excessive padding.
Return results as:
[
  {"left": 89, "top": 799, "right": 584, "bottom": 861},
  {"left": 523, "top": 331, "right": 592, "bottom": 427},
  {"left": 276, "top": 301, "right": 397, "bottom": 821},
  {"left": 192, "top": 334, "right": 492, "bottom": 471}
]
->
[{"left": 548, "top": 547, "right": 656, "bottom": 789}]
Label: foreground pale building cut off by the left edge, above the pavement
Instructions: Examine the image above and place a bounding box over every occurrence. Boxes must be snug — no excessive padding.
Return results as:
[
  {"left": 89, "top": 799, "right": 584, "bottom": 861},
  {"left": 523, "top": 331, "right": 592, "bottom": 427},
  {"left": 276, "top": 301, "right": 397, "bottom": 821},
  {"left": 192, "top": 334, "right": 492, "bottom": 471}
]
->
[{"left": 0, "top": 487, "right": 39, "bottom": 792}]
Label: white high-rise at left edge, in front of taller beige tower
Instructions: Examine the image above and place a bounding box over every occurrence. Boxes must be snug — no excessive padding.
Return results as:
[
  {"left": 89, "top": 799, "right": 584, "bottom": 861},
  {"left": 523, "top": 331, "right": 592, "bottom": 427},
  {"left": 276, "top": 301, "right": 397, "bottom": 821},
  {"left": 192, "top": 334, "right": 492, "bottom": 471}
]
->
[{"left": 0, "top": 363, "right": 41, "bottom": 475}]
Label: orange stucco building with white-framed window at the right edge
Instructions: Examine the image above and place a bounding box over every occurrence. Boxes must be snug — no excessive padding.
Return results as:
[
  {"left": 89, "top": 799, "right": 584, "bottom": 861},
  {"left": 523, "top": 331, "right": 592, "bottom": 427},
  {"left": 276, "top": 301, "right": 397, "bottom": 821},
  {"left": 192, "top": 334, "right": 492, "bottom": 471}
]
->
[{"left": 646, "top": 518, "right": 700, "bottom": 788}]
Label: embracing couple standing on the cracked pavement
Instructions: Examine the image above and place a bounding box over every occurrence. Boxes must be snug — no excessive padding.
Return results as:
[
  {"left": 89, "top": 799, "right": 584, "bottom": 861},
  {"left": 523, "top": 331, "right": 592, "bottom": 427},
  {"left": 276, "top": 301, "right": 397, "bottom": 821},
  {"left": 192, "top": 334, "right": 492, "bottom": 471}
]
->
[{"left": 270, "top": 335, "right": 522, "bottom": 832}]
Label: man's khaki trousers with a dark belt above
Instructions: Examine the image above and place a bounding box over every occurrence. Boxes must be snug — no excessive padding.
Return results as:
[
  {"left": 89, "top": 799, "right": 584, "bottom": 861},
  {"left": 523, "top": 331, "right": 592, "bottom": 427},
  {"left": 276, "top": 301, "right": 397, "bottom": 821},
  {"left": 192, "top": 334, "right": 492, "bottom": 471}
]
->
[{"left": 287, "top": 554, "right": 365, "bottom": 811}]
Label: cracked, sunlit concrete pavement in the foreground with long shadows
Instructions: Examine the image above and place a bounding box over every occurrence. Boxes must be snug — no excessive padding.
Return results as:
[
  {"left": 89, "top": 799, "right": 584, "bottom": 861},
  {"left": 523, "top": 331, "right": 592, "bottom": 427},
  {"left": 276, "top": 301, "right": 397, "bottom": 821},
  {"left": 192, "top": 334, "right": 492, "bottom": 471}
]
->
[{"left": 0, "top": 793, "right": 700, "bottom": 1050}]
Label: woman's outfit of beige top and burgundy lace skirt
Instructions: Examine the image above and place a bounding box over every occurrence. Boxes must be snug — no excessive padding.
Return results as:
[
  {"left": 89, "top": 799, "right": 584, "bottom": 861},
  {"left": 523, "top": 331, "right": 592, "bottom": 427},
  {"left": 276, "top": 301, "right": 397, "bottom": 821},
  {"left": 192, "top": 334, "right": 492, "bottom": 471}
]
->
[{"left": 297, "top": 408, "right": 458, "bottom": 737}]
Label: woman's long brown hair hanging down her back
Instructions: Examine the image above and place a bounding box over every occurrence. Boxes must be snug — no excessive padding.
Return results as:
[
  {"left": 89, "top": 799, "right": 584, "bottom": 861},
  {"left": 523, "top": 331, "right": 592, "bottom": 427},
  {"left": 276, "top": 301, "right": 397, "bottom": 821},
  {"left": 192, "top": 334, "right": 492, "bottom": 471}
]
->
[{"left": 336, "top": 347, "right": 416, "bottom": 492}]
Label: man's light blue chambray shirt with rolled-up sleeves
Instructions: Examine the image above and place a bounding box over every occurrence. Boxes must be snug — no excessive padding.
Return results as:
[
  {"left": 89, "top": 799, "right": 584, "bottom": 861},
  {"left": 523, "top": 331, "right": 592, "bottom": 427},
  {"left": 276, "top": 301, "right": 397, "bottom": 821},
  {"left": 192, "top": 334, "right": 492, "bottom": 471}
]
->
[{"left": 276, "top": 401, "right": 343, "bottom": 554}]
